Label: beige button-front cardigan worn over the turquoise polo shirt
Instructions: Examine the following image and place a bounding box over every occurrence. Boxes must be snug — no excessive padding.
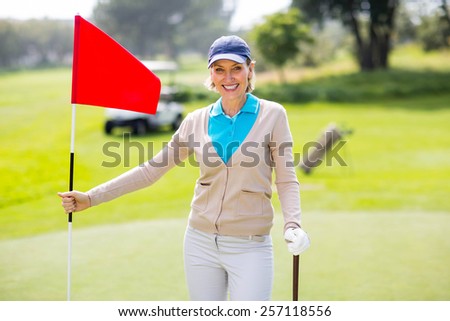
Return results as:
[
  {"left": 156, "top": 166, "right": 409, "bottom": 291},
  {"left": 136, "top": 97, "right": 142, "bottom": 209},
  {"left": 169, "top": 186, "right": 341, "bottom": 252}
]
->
[{"left": 88, "top": 100, "right": 300, "bottom": 236}]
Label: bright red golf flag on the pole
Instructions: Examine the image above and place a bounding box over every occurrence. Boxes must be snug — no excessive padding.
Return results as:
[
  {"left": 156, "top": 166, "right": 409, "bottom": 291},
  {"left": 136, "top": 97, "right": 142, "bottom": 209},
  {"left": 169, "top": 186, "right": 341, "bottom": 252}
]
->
[{"left": 72, "top": 15, "right": 161, "bottom": 114}]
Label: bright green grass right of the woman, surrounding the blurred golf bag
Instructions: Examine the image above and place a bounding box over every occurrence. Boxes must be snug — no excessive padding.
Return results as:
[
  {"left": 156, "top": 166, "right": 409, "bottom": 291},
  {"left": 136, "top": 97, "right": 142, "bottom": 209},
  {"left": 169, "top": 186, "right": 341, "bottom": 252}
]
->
[{"left": 290, "top": 96, "right": 450, "bottom": 211}]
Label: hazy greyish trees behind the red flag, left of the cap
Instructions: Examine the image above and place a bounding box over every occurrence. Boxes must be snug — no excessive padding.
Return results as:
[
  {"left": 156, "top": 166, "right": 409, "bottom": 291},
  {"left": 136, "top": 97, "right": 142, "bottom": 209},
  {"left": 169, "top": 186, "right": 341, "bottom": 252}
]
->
[{"left": 0, "top": 0, "right": 236, "bottom": 69}]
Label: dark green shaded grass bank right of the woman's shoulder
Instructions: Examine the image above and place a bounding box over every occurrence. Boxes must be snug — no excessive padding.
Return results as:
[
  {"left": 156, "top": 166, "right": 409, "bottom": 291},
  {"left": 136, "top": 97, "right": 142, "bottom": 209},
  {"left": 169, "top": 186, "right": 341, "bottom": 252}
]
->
[{"left": 255, "top": 69, "right": 450, "bottom": 109}]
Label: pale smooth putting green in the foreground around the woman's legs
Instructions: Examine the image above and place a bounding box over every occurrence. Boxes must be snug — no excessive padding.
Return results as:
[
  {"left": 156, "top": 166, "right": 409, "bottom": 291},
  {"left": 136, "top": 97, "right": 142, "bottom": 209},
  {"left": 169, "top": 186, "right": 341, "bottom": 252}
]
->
[{"left": 0, "top": 212, "right": 450, "bottom": 301}]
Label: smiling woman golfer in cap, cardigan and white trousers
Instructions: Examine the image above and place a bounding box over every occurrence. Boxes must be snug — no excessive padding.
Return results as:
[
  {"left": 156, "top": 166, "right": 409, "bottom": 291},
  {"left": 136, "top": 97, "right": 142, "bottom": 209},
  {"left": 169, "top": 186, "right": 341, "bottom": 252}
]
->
[{"left": 59, "top": 36, "right": 309, "bottom": 300}]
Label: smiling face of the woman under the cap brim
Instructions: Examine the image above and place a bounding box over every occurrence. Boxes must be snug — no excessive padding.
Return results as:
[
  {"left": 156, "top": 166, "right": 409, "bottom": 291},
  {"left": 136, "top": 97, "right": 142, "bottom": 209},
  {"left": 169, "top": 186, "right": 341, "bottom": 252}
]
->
[{"left": 210, "top": 59, "right": 253, "bottom": 100}]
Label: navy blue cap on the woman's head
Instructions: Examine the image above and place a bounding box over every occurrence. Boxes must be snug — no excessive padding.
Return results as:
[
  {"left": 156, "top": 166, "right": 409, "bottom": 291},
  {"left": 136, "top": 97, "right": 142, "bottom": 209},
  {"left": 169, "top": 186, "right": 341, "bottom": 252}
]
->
[{"left": 208, "top": 36, "right": 251, "bottom": 68}]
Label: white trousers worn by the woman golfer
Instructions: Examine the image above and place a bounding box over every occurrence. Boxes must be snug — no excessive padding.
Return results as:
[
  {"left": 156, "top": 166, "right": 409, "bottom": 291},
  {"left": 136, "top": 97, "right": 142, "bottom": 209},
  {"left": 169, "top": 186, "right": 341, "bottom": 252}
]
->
[{"left": 184, "top": 227, "right": 273, "bottom": 301}]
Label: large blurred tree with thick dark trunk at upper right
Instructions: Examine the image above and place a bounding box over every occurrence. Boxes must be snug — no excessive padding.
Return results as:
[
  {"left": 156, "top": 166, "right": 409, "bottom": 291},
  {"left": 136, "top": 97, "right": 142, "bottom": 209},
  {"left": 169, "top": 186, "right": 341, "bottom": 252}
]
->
[{"left": 292, "top": 0, "right": 399, "bottom": 70}]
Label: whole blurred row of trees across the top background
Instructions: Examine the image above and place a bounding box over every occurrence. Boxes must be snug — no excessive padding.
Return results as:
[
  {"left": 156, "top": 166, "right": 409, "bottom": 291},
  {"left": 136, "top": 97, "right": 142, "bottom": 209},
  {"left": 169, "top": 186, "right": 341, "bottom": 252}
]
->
[{"left": 0, "top": 0, "right": 450, "bottom": 70}]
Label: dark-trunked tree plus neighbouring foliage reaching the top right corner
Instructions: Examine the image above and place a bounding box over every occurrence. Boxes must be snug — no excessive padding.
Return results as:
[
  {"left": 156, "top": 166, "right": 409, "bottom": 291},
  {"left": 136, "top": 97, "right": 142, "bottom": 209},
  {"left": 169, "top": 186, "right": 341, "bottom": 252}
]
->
[{"left": 292, "top": 0, "right": 450, "bottom": 70}]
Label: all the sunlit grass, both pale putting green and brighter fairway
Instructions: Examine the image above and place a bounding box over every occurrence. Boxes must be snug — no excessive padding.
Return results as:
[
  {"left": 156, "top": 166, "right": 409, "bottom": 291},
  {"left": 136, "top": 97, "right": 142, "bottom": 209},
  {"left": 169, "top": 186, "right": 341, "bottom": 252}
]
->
[{"left": 0, "top": 48, "right": 450, "bottom": 300}]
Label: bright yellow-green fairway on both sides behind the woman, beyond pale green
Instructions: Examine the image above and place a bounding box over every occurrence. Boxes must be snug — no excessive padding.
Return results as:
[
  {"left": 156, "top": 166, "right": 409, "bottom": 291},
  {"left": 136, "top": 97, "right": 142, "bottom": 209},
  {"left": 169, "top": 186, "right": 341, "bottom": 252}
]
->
[{"left": 0, "top": 90, "right": 450, "bottom": 238}]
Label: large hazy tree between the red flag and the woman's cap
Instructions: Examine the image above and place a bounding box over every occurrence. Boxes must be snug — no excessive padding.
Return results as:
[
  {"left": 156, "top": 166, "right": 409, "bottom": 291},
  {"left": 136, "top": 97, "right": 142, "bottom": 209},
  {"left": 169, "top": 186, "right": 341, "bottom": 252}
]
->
[{"left": 94, "top": 0, "right": 234, "bottom": 59}]
